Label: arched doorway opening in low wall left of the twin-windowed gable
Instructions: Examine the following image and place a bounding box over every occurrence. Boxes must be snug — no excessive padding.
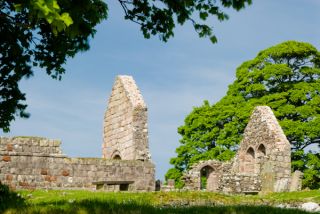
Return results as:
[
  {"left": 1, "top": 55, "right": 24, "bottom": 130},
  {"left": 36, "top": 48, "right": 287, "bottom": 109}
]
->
[{"left": 200, "top": 165, "right": 219, "bottom": 192}]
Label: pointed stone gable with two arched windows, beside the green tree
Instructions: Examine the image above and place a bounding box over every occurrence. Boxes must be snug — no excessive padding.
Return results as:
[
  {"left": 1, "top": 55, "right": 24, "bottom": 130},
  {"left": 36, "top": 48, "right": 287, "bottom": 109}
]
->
[{"left": 233, "top": 106, "right": 291, "bottom": 192}]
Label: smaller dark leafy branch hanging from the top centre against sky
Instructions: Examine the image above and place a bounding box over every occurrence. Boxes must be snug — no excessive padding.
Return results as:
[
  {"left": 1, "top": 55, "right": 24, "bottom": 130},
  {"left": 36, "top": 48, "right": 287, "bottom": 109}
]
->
[{"left": 119, "top": 0, "right": 252, "bottom": 43}]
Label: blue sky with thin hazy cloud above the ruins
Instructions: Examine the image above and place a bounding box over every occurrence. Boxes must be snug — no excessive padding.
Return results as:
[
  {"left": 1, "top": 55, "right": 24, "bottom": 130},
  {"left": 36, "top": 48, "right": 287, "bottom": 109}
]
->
[{"left": 0, "top": 0, "right": 320, "bottom": 179}]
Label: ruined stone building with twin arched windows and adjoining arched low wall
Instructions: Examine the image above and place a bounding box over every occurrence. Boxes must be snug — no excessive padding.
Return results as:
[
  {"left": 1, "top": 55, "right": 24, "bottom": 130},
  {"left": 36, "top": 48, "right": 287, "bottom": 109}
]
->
[{"left": 184, "top": 106, "right": 301, "bottom": 194}]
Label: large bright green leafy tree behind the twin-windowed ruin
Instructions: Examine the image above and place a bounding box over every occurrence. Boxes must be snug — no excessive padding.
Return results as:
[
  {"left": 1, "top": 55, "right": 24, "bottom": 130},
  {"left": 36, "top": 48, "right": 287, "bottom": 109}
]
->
[{"left": 166, "top": 41, "right": 320, "bottom": 188}]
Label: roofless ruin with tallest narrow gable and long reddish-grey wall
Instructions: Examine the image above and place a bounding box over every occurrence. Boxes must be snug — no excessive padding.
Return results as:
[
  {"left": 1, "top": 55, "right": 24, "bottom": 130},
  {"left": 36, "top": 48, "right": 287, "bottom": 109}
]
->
[{"left": 0, "top": 76, "right": 155, "bottom": 191}]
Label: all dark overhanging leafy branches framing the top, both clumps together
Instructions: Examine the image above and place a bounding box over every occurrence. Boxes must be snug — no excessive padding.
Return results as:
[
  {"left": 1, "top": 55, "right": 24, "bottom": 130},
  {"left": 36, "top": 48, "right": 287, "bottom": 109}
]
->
[{"left": 0, "top": 0, "right": 251, "bottom": 132}]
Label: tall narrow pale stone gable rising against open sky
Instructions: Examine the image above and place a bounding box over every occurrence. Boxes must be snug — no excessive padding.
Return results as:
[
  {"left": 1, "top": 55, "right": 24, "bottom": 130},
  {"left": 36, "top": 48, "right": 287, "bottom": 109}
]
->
[{"left": 102, "top": 76, "right": 150, "bottom": 160}]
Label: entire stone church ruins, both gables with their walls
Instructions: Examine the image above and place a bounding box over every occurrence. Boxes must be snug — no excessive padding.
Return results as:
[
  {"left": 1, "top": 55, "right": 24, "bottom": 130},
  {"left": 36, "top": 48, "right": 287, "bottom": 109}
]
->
[{"left": 0, "top": 76, "right": 302, "bottom": 194}]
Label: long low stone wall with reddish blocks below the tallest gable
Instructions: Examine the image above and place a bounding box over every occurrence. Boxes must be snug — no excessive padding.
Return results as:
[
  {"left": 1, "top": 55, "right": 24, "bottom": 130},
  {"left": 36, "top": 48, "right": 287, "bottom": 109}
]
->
[{"left": 0, "top": 137, "right": 155, "bottom": 191}]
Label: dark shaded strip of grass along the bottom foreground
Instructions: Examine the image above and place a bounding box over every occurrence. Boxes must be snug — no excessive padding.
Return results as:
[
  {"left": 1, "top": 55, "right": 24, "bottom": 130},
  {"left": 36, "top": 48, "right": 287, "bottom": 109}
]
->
[{"left": 7, "top": 199, "right": 307, "bottom": 214}]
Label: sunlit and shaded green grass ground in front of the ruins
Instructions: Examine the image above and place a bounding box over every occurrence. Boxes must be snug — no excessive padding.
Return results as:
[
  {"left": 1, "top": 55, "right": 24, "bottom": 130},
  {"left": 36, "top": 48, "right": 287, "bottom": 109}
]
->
[{"left": 0, "top": 186, "right": 320, "bottom": 214}]
